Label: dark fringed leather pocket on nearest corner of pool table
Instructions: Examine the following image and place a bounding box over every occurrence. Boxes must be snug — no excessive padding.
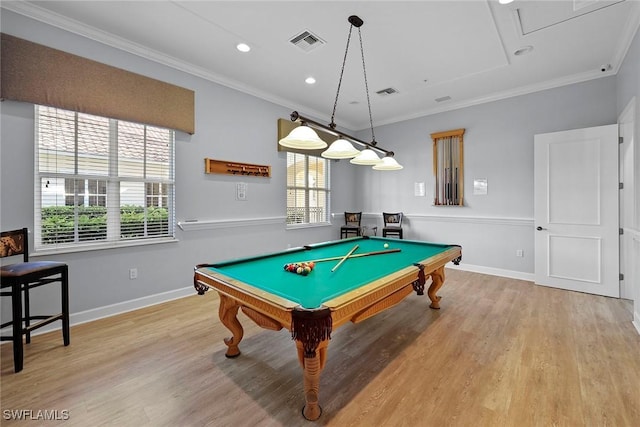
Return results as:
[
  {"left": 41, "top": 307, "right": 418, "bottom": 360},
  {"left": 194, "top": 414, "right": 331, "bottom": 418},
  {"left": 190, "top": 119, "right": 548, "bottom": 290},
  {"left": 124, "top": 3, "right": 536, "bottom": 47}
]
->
[{"left": 291, "top": 308, "right": 333, "bottom": 357}]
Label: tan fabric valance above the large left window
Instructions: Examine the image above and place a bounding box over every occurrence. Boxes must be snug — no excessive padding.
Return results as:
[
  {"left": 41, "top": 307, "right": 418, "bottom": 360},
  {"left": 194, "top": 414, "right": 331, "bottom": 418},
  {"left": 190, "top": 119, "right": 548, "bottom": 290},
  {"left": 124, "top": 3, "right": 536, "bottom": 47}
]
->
[{"left": 0, "top": 33, "right": 195, "bottom": 134}]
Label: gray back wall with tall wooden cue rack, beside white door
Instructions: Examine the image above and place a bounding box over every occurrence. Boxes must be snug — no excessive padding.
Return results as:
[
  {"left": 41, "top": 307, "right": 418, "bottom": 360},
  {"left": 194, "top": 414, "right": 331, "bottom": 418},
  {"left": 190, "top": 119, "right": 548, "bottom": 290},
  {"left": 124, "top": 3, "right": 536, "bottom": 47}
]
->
[{"left": 358, "top": 77, "right": 617, "bottom": 278}]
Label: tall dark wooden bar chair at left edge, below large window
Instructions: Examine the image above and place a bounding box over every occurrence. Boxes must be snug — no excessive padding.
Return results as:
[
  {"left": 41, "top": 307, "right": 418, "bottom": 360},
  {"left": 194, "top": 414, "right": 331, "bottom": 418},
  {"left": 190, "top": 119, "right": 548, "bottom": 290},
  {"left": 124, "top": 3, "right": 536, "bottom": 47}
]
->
[{"left": 0, "top": 228, "right": 69, "bottom": 372}]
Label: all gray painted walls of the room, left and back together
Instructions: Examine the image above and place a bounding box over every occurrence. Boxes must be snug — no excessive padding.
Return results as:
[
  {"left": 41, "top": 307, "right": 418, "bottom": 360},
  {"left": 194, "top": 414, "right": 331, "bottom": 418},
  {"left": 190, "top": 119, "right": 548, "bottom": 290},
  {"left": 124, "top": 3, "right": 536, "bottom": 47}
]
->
[{"left": 0, "top": 10, "right": 640, "bottom": 322}]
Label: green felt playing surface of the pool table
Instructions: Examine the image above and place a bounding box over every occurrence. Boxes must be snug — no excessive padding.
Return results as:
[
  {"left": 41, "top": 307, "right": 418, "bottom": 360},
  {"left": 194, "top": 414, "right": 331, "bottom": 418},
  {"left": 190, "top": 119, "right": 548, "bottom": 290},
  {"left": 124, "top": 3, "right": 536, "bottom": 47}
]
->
[{"left": 208, "top": 237, "right": 453, "bottom": 309}]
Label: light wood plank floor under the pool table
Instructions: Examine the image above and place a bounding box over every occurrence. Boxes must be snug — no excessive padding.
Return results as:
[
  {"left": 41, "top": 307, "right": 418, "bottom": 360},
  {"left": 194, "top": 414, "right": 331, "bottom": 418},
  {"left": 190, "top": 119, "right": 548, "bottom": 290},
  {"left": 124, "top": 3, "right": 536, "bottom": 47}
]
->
[{"left": 0, "top": 270, "right": 640, "bottom": 427}]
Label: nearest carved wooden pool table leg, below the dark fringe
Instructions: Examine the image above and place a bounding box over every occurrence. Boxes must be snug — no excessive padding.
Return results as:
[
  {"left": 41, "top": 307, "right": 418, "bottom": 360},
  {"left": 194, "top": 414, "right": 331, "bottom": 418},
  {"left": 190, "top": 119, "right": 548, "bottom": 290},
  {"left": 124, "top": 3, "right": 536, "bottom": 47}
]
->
[{"left": 296, "top": 340, "right": 329, "bottom": 421}]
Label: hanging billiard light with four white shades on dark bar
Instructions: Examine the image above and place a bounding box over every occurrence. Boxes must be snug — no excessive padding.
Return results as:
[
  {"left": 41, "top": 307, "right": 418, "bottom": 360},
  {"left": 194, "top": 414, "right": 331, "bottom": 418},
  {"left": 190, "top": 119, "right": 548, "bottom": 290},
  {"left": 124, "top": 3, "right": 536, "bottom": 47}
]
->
[{"left": 278, "top": 15, "right": 402, "bottom": 170}]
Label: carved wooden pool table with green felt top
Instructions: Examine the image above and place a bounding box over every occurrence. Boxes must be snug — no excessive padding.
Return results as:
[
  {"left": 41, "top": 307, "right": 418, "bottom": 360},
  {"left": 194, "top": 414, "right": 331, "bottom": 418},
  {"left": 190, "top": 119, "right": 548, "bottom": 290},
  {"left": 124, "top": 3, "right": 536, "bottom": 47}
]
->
[{"left": 194, "top": 236, "right": 462, "bottom": 420}]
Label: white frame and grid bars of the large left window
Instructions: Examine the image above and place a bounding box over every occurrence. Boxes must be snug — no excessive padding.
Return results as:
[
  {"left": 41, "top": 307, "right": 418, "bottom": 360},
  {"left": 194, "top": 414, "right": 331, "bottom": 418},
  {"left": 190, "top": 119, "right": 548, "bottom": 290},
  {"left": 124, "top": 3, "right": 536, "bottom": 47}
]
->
[{"left": 33, "top": 104, "right": 177, "bottom": 256}]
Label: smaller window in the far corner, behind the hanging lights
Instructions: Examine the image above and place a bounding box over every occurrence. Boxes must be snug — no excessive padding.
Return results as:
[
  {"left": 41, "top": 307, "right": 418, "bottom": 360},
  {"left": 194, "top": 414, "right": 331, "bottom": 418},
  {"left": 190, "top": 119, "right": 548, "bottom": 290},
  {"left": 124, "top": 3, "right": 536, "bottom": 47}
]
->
[{"left": 287, "top": 152, "right": 330, "bottom": 225}]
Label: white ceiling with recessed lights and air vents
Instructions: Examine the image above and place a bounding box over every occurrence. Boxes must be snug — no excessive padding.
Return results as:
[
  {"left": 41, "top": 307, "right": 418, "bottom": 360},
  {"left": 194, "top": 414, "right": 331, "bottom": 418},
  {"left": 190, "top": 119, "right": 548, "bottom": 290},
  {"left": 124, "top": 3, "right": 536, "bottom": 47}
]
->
[{"left": 2, "top": 0, "right": 640, "bottom": 130}]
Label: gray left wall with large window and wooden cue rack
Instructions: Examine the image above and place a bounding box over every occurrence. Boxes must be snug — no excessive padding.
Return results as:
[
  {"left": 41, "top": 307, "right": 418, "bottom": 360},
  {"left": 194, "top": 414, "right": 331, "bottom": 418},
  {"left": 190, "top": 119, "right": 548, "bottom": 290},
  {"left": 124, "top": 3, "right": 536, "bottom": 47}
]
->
[{"left": 0, "top": 10, "right": 355, "bottom": 319}]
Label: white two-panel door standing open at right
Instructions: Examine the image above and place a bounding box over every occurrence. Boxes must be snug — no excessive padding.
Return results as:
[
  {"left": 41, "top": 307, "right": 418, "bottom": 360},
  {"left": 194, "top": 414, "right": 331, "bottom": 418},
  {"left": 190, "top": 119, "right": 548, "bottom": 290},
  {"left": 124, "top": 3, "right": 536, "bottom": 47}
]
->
[{"left": 534, "top": 125, "right": 620, "bottom": 297}]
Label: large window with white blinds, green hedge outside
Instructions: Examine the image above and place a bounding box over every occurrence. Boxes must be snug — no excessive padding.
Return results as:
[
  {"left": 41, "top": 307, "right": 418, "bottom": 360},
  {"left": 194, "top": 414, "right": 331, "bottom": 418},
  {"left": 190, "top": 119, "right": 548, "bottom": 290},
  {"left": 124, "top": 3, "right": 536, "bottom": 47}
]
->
[{"left": 34, "top": 106, "right": 174, "bottom": 250}]
